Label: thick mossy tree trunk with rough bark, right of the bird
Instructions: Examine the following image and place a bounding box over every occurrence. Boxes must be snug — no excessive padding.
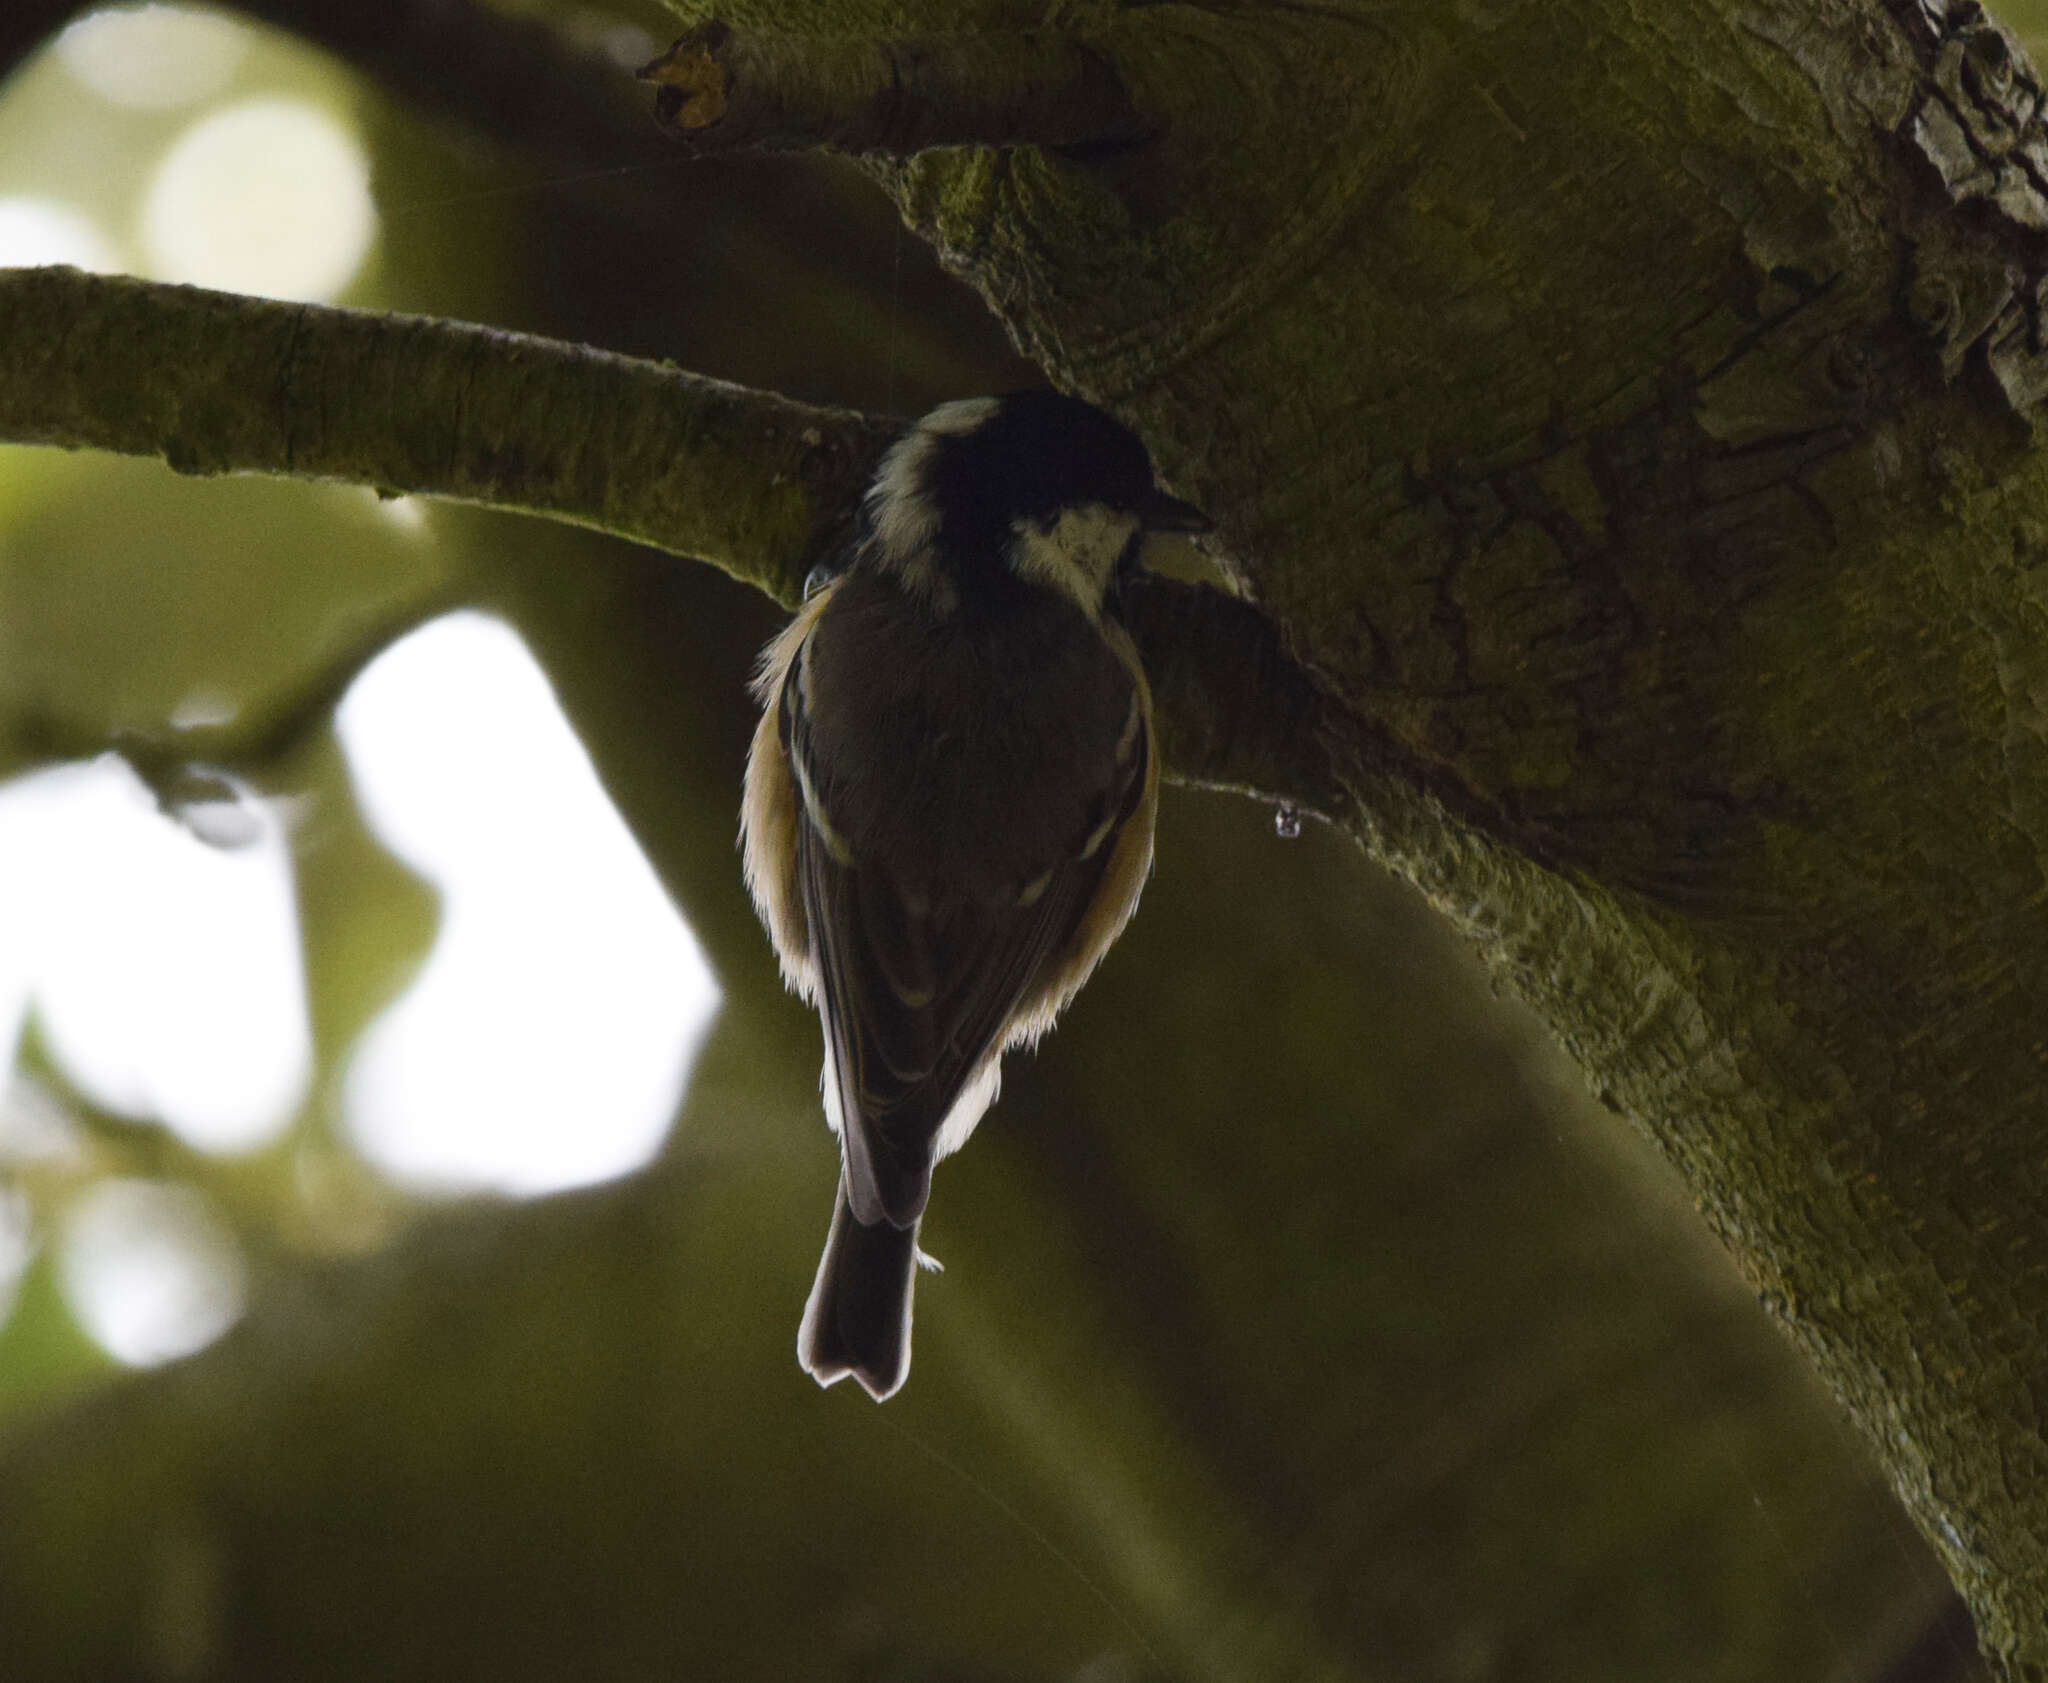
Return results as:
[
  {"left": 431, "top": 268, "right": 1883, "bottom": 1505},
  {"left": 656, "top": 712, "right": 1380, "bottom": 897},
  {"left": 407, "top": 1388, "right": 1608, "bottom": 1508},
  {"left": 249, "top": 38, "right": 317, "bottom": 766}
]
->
[{"left": 891, "top": 0, "right": 2048, "bottom": 1677}]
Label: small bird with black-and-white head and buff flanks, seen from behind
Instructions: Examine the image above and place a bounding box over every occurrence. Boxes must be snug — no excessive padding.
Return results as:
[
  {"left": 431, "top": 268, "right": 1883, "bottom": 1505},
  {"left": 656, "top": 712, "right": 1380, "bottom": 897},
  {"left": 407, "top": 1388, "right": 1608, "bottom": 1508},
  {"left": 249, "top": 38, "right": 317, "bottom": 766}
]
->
[{"left": 741, "top": 391, "right": 1208, "bottom": 1403}]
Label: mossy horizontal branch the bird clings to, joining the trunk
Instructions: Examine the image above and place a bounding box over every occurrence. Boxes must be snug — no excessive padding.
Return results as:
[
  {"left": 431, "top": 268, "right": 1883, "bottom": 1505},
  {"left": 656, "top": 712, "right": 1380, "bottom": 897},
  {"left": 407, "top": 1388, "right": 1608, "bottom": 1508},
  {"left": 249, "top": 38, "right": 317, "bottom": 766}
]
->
[{"left": 0, "top": 268, "right": 1356, "bottom": 813}]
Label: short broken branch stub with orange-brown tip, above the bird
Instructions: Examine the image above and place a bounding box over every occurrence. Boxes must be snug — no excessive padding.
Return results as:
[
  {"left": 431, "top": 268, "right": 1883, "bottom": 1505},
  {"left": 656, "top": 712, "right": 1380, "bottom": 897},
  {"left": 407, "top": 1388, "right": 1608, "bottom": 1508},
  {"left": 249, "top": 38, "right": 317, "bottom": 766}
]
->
[{"left": 641, "top": 23, "right": 1145, "bottom": 158}]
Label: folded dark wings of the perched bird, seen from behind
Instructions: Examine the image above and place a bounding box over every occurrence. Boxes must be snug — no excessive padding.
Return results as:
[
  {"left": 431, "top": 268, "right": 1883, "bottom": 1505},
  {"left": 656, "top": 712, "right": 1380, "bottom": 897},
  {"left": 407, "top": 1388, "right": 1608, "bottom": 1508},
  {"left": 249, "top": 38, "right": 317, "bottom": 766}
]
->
[{"left": 778, "top": 638, "right": 1149, "bottom": 1226}]
